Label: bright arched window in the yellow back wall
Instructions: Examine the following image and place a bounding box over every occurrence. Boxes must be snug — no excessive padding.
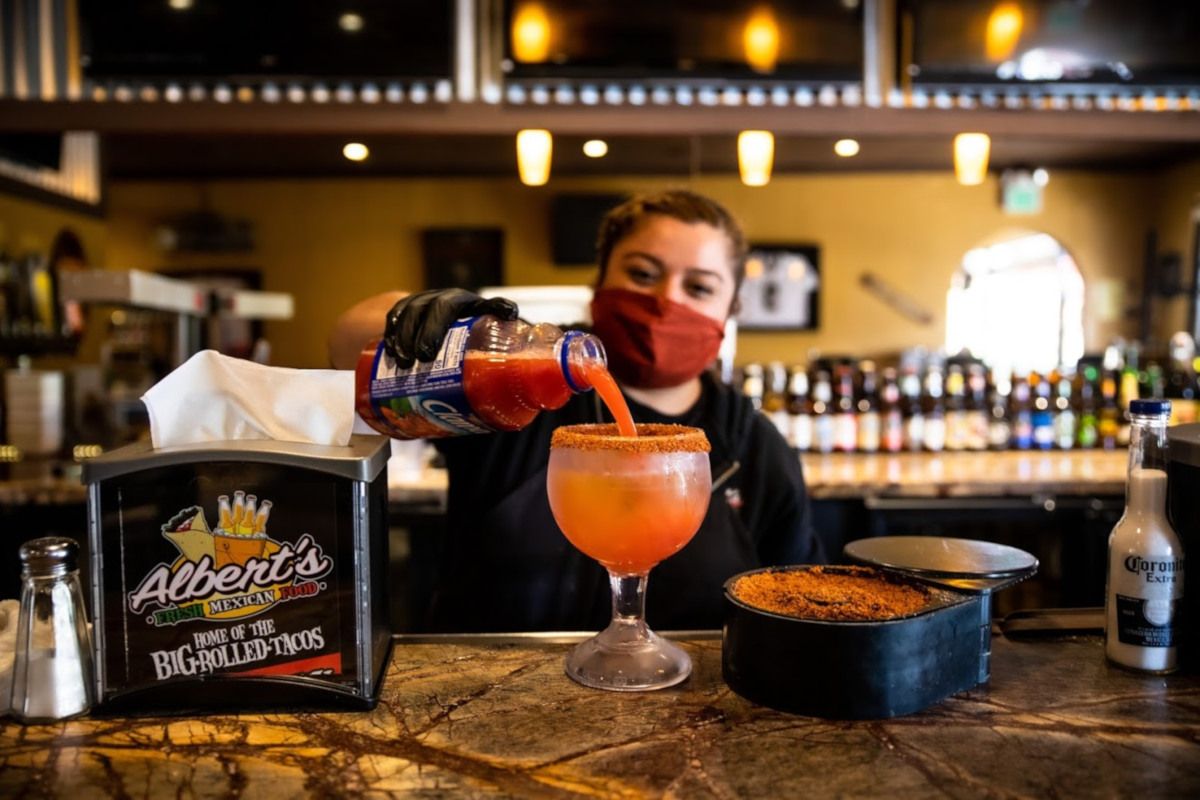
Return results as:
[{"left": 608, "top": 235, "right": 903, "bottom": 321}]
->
[{"left": 946, "top": 231, "right": 1084, "bottom": 374}]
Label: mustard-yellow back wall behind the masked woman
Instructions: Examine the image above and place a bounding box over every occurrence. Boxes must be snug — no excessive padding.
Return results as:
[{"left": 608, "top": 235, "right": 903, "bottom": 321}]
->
[{"left": 100, "top": 169, "right": 1171, "bottom": 367}]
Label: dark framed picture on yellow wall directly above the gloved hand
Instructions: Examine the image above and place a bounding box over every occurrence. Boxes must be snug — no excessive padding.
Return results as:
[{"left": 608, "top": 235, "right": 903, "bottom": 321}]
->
[{"left": 421, "top": 228, "right": 504, "bottom": 291}]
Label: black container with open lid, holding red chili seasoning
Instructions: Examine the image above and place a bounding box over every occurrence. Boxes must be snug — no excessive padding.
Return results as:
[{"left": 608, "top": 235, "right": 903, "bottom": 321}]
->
[{"left": 721, "top": 537, "right": 1037, "bottom": 720}]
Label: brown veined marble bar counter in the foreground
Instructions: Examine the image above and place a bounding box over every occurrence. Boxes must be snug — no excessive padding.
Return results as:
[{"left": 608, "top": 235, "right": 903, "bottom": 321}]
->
[{"left": 0, "top": 634, "right": 1200, "bottom": 800}]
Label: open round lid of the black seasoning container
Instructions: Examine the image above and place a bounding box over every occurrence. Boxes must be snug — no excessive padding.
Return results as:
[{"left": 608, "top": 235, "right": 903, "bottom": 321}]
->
[{"left": 844, "top": 536, "right": 1038, "bottom": 594}]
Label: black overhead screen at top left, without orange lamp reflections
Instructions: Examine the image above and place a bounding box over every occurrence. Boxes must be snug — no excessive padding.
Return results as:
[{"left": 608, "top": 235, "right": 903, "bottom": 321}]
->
[{"left": 79, "top": 0, "right": 455, "bottom": 79}]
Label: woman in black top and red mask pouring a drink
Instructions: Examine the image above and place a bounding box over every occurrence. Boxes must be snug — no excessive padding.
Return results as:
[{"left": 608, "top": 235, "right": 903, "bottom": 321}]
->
[{"left": 330, "top": 190, "right": 824, "bottom": 632}]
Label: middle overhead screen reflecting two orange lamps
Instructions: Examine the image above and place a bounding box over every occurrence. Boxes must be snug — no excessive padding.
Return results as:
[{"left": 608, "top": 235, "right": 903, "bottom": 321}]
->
[{"left": 503, "top": 0, "right": 863, "bottom": 82}]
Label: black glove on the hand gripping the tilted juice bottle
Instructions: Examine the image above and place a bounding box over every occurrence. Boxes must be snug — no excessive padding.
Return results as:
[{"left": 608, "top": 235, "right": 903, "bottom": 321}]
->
[{"left": 383, "top": 289, "right": 517, "bottom": 369}]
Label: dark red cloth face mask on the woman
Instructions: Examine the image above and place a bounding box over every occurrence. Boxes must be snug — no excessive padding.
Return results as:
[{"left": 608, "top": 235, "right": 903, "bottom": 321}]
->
[{"left": 592, "top": 289, "right": 725, "bottom": 389}]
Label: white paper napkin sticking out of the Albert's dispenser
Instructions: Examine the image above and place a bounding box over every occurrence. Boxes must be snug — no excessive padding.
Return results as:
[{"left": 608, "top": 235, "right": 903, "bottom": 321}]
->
[{"left": 142, "top": 350, "right": 370, "bottom": 447}]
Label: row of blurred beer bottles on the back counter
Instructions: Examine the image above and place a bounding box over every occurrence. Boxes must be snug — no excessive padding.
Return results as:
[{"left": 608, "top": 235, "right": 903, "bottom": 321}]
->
[{"left": 740, "top": 360, "right": 1200, "bottom": 453}]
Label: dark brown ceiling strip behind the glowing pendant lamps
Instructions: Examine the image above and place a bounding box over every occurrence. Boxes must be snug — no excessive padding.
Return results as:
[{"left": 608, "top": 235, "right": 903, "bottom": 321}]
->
[{"left": 103, "top": 132, "right": 1200, "bottom": 180}]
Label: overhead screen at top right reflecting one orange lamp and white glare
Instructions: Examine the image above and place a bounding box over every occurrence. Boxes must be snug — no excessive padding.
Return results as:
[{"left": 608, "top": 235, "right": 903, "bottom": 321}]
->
[{"left": 898, "top": 0, "right": 1200, "bottom": 88}]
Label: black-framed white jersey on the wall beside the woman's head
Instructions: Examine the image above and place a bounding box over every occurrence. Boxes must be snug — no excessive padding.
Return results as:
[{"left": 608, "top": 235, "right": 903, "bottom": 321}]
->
[{"left": 738, "top": 243, "right": 821, "bottom": 331}]
